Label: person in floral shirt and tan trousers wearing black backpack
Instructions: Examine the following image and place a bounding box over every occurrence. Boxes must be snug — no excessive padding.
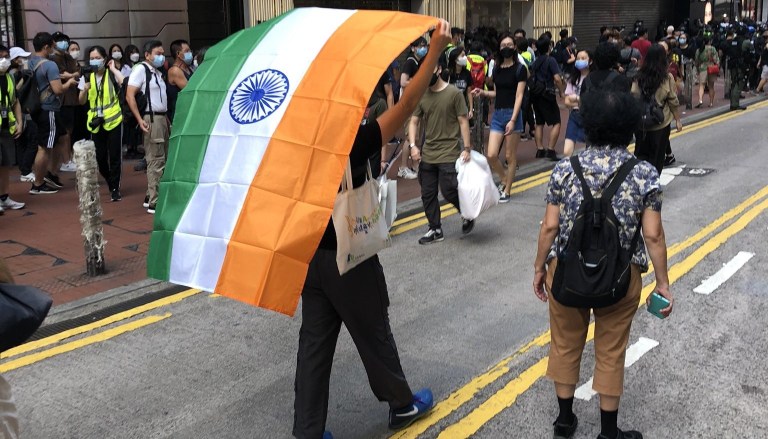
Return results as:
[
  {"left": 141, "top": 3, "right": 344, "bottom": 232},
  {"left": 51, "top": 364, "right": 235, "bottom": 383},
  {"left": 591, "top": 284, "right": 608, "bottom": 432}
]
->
[{"left": 533, "top": 87, "right": 674, "bottom": 439}]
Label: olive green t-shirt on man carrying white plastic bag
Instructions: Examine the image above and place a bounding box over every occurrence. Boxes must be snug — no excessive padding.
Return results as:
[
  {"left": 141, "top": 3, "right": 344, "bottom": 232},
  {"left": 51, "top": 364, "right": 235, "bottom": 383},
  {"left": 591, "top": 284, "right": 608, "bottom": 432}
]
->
[{"left": 413, "top": 85, "right": 469, "bottom": 164}]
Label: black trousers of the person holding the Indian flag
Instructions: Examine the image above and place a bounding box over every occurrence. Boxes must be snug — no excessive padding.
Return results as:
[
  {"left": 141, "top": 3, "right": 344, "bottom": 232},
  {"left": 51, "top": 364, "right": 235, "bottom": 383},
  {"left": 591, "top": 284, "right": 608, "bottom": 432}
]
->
[{"left": 293, "top": 249, "right": 413, "bottom": 439}]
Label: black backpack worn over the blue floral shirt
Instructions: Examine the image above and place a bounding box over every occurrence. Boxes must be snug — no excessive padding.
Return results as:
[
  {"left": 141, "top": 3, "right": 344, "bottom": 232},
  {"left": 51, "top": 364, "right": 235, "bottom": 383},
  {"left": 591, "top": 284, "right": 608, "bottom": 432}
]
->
[{"left": 552, "top": 156, "right": 641, "bottom": 308}]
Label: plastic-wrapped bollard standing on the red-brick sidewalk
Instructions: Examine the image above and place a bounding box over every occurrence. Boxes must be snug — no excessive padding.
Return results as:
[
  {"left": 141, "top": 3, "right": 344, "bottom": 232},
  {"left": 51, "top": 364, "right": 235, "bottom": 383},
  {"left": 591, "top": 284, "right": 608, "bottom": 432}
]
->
[{"left": 74, "top": 140, "right": 107, "bottom": 276}]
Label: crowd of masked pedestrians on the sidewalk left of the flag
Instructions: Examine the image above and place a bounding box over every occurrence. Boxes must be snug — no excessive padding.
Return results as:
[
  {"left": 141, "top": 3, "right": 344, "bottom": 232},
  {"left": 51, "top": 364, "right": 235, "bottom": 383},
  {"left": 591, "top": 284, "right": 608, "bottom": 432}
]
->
[{"left": 0, "top": 32, "right": 205, "bottom": 214}]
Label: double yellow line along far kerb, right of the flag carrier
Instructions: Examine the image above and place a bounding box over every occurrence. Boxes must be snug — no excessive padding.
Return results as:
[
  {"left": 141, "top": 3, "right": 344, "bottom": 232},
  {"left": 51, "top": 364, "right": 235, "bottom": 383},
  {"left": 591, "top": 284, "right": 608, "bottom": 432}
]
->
[{"left": 390, "top": 101, "right": 768, "bottom": 236}]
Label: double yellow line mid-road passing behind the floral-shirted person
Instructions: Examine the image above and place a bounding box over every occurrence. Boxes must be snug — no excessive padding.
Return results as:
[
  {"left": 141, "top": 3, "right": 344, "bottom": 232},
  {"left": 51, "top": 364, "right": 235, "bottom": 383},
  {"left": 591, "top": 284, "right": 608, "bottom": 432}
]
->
[{"left": 391, "top": 186, "right": 768, "bottom": 439}]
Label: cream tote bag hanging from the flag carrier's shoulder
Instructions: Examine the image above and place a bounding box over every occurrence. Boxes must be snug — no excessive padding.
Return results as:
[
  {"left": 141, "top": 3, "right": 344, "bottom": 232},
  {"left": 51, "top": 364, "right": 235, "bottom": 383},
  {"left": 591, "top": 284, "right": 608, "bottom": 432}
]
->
[{"left": 333, "top": 158, "right": 390, "bottom": 275}]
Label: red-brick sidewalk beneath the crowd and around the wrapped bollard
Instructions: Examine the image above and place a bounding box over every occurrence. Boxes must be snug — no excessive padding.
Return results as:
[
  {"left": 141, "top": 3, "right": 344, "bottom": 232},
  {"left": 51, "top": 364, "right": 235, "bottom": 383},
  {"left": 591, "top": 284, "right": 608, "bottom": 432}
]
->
[{"left": 0, "top": 80, "right": 764, "bottom": 305}]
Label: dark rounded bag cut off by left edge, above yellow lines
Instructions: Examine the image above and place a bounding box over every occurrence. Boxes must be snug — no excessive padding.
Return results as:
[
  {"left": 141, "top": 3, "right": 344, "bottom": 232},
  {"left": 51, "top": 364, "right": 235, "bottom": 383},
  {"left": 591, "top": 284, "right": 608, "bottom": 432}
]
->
[{"left": 0, "top": 284, "right": 53, "bottom": 352}]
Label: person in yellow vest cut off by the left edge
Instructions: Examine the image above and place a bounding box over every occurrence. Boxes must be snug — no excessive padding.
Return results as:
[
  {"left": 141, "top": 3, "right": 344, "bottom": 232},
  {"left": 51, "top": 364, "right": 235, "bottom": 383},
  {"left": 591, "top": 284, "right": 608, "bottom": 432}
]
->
[{"left": 0, "top": 46, "right": 24, "bottom": 213}]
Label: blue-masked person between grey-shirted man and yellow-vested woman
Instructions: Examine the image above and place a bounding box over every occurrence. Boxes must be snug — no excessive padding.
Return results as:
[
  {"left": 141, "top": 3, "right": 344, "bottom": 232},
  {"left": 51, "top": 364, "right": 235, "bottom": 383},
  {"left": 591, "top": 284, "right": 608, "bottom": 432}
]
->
[{"left": 51, "top": 32, "right": 80, "bottom": 172}]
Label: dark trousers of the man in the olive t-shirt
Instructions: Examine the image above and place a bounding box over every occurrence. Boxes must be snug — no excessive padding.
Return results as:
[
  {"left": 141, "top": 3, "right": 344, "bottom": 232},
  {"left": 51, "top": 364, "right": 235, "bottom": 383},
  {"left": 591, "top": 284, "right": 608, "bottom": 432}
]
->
[{"left": 419, "top": 161, "right": 461, "bottom": 230}]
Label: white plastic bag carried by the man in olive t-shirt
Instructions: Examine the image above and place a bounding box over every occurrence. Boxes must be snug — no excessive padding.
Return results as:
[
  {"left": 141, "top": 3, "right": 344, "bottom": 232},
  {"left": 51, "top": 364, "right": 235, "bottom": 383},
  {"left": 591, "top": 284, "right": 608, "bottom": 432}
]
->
[{"left": 456, "top": 151, "right": 499, "bottom": 220}]
